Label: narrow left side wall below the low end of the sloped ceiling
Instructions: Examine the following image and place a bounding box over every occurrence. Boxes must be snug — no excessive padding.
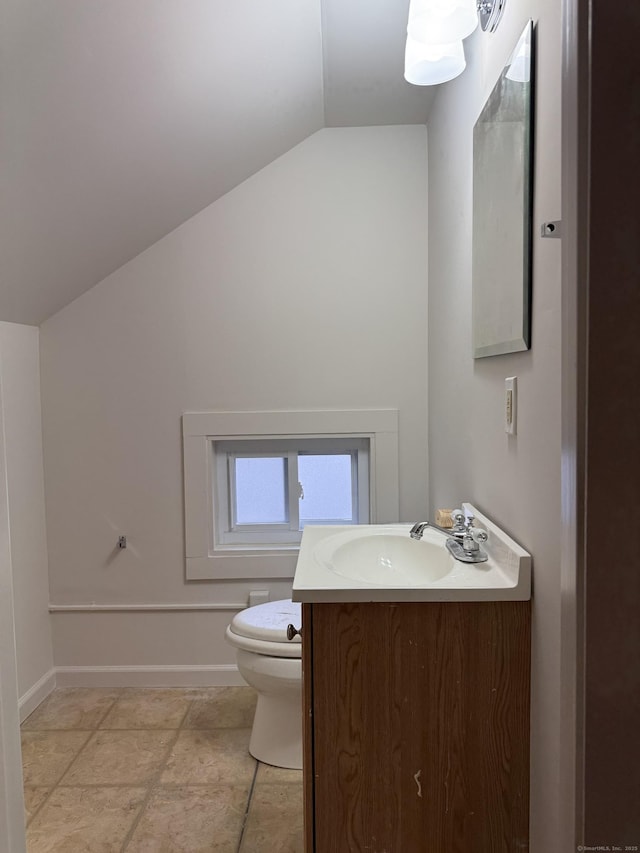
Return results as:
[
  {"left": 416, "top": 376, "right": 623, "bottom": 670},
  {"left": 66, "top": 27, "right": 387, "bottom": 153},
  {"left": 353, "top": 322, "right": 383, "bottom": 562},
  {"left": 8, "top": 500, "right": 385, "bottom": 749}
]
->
[{"left": 0, "top": 323, "right": 54, "bottom": 717}]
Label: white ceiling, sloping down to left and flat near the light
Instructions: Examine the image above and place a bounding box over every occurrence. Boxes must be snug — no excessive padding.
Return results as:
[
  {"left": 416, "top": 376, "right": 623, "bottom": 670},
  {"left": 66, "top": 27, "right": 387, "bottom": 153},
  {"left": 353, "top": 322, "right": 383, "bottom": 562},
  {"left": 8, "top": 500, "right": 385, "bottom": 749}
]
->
[{"left": 0, "top": 0, "right": 432, "bottom": 325}]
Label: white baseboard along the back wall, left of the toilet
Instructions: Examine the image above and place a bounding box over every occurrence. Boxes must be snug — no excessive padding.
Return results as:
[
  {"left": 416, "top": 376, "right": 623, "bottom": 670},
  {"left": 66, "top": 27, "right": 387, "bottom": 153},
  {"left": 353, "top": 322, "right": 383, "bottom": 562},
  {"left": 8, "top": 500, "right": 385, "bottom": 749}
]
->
[{"left": 54, "top": 664, "right": 246, "bottom": 698}]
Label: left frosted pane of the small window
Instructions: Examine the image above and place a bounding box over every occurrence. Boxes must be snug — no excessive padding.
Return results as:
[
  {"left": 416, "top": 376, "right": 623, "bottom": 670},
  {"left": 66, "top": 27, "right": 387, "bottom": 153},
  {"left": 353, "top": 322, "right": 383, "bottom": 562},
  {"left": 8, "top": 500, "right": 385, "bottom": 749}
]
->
[{"left": 236, "top": 456, "right": 289, "bottom": 524}]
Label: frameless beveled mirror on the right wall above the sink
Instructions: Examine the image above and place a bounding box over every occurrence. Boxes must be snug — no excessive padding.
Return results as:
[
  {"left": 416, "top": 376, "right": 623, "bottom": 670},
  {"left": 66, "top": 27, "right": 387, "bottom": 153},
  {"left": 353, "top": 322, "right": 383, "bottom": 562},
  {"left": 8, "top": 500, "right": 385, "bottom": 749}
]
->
[{"left": 472, "top": 21, "right": 534, "bottom": 358}]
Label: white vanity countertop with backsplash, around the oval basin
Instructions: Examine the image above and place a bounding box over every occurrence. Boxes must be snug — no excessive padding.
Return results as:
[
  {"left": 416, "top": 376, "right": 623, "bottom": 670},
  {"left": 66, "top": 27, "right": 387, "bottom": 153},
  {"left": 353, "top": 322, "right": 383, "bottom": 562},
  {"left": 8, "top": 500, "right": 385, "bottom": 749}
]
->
[{"left": 292, "top": 504, "right": 531, "bottom": 603}]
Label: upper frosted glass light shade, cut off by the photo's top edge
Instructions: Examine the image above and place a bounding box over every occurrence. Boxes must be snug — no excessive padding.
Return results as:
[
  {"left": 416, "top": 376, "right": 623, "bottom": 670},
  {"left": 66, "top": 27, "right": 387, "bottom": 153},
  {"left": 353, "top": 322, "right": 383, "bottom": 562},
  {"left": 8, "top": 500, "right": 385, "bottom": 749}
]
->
[{"left": 407, "top": 0, "right": 478, "bottom": 44}]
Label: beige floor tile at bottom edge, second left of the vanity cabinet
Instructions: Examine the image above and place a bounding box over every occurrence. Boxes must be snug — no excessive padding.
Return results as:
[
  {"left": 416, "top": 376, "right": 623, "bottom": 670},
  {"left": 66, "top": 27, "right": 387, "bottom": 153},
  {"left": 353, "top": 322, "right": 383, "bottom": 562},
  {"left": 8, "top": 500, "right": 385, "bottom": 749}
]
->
[{"left": 126, "top": 785, "right": 249, "bottom": 853}]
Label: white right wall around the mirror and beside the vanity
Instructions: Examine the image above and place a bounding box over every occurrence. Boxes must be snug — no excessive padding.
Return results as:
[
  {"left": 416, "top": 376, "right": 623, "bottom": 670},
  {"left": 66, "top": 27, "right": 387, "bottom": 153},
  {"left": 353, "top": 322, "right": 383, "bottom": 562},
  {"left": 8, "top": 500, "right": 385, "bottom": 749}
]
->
[{"left": 428, "top": 6, "right": 561, "bottom": 853}]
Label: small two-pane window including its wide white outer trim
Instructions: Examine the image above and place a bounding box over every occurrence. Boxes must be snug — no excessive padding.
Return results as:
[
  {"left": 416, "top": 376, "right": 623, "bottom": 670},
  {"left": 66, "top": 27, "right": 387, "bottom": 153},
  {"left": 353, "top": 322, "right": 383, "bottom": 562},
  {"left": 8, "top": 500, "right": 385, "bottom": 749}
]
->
[{"left": 182, "top": 409, "right": 398, "bottom": 580}]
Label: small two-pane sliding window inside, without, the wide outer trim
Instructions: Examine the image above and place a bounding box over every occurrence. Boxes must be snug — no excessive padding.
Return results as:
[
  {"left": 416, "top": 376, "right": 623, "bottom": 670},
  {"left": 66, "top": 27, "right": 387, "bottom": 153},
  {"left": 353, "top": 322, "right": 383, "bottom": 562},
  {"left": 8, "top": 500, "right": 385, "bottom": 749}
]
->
[{"left": 211, "top": 436, "right": 369, "bottom": 545}]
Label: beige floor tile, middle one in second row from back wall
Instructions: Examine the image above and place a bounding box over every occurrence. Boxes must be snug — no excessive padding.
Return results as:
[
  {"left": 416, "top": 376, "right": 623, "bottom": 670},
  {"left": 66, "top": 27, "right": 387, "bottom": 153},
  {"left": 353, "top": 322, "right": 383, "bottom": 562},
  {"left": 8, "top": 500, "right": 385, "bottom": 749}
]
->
[{"left": 63, "top": 731, "right": 175, "bottom": 785}]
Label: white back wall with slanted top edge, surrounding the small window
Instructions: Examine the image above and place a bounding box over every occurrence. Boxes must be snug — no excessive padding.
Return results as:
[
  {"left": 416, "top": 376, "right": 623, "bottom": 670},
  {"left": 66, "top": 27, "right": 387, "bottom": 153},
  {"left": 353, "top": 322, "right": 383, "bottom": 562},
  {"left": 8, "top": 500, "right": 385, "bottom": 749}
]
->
[{"left": 41, "top": 126, "right": 427, "bottom": 678}]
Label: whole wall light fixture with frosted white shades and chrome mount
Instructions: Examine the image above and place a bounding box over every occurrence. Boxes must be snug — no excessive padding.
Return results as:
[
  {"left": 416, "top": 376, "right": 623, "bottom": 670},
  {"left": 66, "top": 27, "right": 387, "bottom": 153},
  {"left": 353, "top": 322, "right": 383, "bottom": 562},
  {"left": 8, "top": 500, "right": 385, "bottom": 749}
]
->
[{"left": 404, "top": 0, "right": 507, "bottom": 86}]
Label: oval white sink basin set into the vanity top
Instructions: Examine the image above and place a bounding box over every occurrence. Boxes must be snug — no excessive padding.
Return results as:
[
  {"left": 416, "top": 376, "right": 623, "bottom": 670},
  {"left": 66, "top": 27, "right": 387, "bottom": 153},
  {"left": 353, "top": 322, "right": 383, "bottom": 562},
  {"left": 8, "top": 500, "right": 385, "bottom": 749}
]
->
[{"left": 315, "top": 527, "right": 455, "bottom": 586}]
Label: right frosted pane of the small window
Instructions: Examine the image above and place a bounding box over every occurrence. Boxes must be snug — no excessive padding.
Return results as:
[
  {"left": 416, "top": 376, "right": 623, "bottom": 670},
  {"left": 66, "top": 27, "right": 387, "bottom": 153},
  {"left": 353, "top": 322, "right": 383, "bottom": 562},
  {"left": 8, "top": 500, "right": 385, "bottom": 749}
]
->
[{"left": 298, "top": 453, "right": 353, "bottom": 527}]
